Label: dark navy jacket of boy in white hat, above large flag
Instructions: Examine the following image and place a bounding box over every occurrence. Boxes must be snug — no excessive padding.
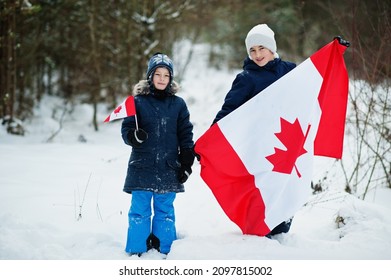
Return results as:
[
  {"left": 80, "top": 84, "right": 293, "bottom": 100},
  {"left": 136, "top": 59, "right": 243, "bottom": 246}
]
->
[{"left": 213, "top": 57, "right": 296, "bottom": 123}]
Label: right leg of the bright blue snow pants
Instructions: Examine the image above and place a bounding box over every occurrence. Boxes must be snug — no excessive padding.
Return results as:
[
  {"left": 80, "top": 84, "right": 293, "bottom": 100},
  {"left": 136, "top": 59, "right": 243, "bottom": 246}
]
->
[{"left": 152, "top": 193, "right": 176, "bottom": 254}]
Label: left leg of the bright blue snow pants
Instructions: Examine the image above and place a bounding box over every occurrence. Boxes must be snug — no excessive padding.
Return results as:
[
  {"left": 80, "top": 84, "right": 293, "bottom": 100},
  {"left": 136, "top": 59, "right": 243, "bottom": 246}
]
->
[{"left": 125, "top": 191, "right": 153, "bottom": 254}]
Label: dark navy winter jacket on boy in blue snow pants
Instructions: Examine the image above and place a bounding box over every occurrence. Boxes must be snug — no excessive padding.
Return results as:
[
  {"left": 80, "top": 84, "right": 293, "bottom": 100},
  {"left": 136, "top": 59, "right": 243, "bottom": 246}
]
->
[{"left": 121, "top": 80, "right": 194, "bottom": 193}]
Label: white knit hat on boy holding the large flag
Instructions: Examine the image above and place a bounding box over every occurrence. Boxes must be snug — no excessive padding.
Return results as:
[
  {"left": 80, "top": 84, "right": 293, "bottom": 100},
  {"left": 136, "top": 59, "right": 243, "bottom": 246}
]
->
[{"left": 245, "top": 24, "right": 278, "bottom": 58}]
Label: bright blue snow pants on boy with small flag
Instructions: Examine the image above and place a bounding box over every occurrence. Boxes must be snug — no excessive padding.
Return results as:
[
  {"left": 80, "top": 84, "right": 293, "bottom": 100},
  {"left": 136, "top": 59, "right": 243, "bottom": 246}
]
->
[{"left": 125, "top": 191, "right": 176, "bottom": 254}]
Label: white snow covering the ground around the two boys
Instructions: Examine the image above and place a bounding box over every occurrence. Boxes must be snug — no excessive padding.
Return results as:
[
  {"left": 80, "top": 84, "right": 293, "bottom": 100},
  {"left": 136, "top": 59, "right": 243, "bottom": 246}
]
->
[{"left": 0, "top": 45, "right": 391, "bottom": 279}]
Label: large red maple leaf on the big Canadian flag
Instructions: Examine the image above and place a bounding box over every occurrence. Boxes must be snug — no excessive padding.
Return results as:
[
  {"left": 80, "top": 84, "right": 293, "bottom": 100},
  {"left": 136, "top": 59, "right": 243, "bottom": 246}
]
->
[{"left": 266, "top": 118, "right": 311, "bottom": 177}]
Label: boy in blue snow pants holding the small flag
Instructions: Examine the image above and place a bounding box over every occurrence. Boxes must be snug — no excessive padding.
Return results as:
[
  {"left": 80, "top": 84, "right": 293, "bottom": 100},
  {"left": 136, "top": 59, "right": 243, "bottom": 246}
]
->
[{"left": 121, "top": 53, "right": 194, "bottom": 256}]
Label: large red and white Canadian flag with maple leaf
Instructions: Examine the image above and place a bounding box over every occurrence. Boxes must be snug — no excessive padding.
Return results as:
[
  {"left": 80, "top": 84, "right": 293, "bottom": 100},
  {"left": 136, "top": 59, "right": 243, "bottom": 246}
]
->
[{"left": 195, "top": 38, "right": 349, "bottom": 236}]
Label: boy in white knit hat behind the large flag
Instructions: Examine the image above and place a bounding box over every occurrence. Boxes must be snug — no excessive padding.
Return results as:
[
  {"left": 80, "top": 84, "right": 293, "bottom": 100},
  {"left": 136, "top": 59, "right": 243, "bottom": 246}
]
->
[{"left": 213, "top": 24, "right": 296, "bottom": 237}]
